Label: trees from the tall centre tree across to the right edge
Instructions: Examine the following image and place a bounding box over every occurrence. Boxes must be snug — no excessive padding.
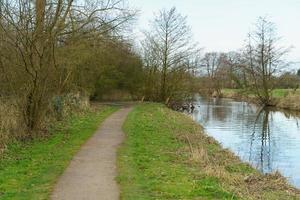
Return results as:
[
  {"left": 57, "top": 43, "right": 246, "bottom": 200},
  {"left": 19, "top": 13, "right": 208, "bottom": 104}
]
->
[{"left": 142, "top": 8, "right": 300, "bottom": 108}]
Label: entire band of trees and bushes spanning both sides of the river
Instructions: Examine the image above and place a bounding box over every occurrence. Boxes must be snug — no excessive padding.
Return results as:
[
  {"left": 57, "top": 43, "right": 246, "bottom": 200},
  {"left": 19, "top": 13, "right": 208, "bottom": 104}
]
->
[{"left": 0, "top": 0, "right": 299, "bottom": 146}]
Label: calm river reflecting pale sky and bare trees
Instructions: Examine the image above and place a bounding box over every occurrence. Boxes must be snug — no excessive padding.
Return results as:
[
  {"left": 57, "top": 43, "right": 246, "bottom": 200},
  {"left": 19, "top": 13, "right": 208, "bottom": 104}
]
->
[{"left": 192, "top": 97, "right": 300, "bottom": 188}]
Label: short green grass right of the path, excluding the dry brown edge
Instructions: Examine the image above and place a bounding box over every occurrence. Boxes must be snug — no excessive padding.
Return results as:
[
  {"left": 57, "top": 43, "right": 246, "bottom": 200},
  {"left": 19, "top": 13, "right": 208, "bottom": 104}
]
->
[{"left": 119, "top": 105, "right": 234, "bottom": 200}]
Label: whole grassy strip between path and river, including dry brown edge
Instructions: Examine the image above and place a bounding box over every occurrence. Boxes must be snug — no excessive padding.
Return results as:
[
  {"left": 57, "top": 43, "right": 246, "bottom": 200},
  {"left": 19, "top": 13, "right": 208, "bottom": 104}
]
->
[{"left": 118, "top": 104, "right": 300, "bottom": 200}]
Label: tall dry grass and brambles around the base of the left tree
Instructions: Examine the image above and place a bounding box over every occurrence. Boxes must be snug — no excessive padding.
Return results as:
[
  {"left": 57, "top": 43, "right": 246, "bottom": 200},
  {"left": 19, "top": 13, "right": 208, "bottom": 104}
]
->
[{"left": 0, "top": 94, "right": 90, "bottom": 154}]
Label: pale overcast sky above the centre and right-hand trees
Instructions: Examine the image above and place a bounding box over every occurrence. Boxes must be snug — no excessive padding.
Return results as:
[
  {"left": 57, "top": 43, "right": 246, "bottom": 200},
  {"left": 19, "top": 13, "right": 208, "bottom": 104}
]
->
[{"left": 129, "top": 0, "right": 300, "bottom": 61}]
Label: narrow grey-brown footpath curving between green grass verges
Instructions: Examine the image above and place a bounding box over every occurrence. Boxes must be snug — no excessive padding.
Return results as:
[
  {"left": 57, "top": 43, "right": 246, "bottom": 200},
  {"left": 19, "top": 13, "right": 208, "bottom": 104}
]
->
[{"left": 51, "top": 107, "right": 131, "bottom": 200}]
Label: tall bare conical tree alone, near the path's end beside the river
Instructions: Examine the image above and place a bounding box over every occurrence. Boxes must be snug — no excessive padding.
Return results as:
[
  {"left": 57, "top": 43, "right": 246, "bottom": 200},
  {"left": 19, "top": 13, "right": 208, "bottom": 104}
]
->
[{"left": 144, "top": 8, "right": 195, "bottom": 101}]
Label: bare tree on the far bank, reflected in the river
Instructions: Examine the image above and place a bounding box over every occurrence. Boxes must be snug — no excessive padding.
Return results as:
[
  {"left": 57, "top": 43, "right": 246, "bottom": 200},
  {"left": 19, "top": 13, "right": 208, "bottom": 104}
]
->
[{"left": 245, "top": 17, "right": 289, "bottom": 105}]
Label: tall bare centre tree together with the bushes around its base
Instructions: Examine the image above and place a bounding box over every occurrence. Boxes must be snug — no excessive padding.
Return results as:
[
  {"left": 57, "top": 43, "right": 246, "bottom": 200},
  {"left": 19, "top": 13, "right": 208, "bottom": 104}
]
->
[{"left": 142, "top": 8, "right": 200, "bottom": 105}]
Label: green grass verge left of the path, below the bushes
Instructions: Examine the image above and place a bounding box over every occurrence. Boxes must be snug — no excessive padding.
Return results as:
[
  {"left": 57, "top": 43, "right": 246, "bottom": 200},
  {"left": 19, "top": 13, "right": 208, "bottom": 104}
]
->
[{"left": 0, "top": 107, "right": 117, "bottom": 200}]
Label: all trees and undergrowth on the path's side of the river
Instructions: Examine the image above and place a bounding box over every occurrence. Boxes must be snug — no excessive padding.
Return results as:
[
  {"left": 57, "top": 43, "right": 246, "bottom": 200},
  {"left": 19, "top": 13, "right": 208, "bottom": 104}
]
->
[{"left": 0, "top": 0, "right": 199, "bottom": 145}]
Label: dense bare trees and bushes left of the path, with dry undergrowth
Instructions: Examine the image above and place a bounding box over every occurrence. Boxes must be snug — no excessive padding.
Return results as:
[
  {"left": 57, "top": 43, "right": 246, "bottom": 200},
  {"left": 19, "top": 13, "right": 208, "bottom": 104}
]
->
[{"left": 0, "top": 0, "right": 143, "bottom": 145}]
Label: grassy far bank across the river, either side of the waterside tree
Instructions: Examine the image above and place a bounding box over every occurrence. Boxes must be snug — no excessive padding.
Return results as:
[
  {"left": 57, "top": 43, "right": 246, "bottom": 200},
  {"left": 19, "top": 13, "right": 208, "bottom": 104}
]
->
[{"left": 222, "top": 89, "right": 300, "bottom": 111}]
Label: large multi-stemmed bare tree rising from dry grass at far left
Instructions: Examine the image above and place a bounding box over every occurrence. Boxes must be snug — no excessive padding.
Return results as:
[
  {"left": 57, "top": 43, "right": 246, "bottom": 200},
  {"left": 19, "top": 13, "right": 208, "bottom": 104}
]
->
[{"left": 0, "top": 0, "right": 135, "bottom": 133}]
